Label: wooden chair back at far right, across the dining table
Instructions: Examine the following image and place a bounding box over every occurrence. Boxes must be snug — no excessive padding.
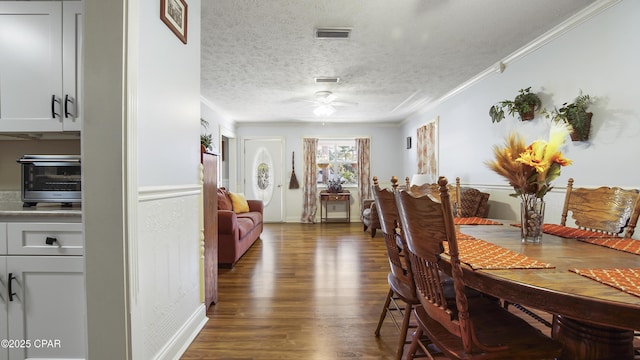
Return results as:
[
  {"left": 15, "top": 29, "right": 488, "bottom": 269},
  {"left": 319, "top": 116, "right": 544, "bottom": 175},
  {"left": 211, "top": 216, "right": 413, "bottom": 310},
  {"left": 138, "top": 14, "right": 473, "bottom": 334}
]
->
[{"left": 560, "top": 178, "right": 640, "bottom": 237}]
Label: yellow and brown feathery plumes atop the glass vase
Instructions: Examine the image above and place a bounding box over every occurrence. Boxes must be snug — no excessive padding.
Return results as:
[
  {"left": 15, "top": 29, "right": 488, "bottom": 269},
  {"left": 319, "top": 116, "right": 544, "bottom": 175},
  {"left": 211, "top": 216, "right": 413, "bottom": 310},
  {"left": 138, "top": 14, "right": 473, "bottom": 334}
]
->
[{"left": 486, "top": 123, "right": 571, "bottom": 201}]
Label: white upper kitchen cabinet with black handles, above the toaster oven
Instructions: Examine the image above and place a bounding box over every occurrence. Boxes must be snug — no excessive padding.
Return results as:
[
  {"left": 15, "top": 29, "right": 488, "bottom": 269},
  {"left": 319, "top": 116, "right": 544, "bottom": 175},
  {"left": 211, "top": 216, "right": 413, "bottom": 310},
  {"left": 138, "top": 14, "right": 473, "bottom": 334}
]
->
[{"left": 0, "top": 1, "right": 82, "bottom": 132}]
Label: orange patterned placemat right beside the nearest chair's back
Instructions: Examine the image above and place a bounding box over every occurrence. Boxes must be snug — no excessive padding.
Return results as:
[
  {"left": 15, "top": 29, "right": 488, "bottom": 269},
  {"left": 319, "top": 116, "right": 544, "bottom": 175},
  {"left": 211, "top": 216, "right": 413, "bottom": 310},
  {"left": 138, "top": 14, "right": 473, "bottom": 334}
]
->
[{"left": 444, "top": 235, "right": 554, "bottom": 270}]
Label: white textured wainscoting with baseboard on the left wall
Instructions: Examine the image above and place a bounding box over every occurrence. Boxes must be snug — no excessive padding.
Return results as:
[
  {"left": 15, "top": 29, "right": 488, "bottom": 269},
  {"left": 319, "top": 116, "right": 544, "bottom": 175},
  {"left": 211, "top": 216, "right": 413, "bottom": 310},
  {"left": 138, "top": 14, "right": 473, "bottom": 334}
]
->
[{"left": 131, "top": 185, "right": 206, "bottom": 359}]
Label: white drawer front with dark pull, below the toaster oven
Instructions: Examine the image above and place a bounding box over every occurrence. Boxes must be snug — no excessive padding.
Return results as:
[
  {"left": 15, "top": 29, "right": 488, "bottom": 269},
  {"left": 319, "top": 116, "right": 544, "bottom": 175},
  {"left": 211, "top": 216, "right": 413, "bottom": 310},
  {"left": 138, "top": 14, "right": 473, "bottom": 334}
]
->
[{"left": 6, "top": 223, "right": 84, "bottom": 255}]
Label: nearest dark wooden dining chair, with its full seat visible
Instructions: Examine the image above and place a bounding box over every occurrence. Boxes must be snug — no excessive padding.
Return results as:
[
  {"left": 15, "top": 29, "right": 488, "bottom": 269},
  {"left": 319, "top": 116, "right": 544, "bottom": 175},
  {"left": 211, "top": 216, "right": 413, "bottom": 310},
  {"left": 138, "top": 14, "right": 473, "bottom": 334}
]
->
[{"left": 396, "top": 177, "right": 562, "bottom": 359}]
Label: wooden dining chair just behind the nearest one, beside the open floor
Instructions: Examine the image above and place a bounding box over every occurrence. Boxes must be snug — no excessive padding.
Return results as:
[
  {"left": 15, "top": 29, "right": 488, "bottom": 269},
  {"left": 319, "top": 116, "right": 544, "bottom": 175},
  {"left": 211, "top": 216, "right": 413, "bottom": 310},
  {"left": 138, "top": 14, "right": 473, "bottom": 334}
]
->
[{"left": 372, "top": 176, "right": 420, "bottom": 359}]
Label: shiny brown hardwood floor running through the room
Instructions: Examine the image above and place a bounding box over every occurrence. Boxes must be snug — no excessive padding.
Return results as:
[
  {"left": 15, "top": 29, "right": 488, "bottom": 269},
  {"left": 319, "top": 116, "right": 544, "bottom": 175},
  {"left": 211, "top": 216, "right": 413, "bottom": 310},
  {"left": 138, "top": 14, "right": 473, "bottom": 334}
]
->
[{"left": 182, "top": 223, "right": 640, "bottom": 360}]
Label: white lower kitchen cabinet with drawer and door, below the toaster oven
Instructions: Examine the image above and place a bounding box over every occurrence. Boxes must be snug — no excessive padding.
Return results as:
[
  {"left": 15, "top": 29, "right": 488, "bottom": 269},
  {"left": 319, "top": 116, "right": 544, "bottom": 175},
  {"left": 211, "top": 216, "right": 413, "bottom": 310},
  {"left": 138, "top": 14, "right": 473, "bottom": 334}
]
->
[{"left": 0, "top": 217, "right": 86, "bottom": 360}]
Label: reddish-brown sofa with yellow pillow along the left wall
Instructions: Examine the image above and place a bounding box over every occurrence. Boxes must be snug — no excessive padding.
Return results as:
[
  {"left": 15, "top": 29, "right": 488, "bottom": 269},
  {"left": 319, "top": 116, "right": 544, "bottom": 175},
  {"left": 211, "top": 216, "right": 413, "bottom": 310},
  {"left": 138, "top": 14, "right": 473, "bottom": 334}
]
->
[{"left": 218, "top": 189, "right": 264, "bottom": 268}]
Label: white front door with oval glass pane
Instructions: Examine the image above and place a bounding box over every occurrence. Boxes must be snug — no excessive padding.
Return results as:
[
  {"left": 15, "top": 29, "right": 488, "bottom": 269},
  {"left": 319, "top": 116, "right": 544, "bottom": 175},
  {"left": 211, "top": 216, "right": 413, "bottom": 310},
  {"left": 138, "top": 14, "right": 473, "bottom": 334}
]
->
[{"left": 244, "top": 138, "right": 284, "bottom": 222}]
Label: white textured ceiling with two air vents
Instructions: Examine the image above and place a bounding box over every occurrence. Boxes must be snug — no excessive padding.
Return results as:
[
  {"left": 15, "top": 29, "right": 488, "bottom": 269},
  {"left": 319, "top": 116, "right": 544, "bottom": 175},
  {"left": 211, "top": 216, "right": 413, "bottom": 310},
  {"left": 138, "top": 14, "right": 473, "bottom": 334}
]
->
[{"left": 201, "top": 0, "right": 594, "bottom": 122}]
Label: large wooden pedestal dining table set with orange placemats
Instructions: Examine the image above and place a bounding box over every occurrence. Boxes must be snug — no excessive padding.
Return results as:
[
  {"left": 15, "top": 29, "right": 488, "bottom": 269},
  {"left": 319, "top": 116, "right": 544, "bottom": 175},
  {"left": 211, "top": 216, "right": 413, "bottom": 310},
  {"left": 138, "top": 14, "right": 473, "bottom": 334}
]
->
[{"left": 443, "top": 221, "right": 640, "bottom": 360}]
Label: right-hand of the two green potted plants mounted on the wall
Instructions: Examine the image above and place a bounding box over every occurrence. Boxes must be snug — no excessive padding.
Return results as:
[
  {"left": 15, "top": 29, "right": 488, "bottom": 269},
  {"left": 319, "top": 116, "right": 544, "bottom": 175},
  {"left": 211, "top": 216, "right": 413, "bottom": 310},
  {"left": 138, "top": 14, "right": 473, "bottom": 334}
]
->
[{"left": 546, "top": 91, "right": 593, "bottom": 141}]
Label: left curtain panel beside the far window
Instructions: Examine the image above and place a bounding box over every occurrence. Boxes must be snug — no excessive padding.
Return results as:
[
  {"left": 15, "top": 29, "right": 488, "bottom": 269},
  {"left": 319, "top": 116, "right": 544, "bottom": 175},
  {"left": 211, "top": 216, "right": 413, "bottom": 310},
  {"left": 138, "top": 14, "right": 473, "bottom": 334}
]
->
[{"left": 301, "top": 138, "right": 318, "bottom": 223}]
